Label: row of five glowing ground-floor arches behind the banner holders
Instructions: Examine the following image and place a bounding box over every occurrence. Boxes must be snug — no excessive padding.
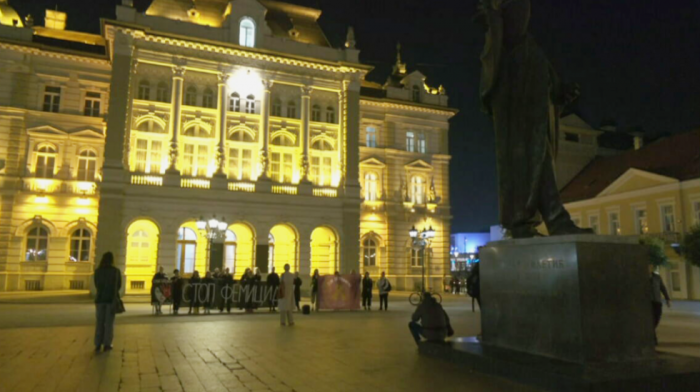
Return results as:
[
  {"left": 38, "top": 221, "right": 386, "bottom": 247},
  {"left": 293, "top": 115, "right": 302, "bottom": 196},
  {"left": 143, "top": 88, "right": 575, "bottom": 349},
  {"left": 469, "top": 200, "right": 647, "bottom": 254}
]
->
[{"left": 125, "top": 219, "right": 340, "bottom": 293}]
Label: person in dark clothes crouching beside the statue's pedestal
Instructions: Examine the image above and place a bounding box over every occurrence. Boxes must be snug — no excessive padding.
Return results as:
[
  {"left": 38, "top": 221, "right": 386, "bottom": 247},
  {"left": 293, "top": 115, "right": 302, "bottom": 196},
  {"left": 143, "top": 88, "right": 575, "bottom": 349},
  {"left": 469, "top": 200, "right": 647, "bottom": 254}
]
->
[{"left": 408, "top": 293, "right": 454, "bottom": 344}]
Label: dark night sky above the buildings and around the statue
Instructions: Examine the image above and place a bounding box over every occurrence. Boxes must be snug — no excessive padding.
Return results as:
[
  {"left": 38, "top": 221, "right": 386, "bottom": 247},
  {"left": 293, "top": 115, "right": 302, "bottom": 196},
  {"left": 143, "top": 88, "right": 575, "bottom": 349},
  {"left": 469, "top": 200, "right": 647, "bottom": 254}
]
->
[{"left": 10, "top": 0, "right": 700, "bottom": 232}]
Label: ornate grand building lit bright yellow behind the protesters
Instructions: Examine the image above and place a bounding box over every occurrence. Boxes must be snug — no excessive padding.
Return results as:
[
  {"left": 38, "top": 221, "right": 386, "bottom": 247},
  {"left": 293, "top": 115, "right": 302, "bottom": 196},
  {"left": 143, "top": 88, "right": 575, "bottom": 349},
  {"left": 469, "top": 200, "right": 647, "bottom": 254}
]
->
[{"left": 0, "top": 0, "right": 455, "bottom": 293}]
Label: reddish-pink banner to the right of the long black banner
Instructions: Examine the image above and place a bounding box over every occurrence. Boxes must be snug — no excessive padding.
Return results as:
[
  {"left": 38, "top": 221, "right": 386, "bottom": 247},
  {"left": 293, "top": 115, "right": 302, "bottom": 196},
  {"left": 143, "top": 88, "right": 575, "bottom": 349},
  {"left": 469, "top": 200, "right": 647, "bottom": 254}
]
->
[{"left": 318, "top": 274, "right": 361, "bottom": 310}]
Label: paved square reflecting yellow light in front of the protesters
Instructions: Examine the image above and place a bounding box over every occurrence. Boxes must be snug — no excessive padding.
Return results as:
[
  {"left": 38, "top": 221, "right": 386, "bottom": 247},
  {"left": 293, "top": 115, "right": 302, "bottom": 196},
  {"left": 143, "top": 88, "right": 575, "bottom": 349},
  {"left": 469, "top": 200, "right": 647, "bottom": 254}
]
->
[{"left": 0, "top": 296, "right": 700, "bottom": 392}]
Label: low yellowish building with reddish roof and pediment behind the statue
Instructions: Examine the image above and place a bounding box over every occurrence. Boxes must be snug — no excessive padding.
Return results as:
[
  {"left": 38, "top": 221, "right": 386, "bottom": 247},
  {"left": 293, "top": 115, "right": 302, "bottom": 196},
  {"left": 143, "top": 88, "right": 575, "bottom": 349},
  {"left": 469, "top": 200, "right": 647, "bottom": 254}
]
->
[{"left": 561, "top": 131, "right": 700, "bottom": 300}]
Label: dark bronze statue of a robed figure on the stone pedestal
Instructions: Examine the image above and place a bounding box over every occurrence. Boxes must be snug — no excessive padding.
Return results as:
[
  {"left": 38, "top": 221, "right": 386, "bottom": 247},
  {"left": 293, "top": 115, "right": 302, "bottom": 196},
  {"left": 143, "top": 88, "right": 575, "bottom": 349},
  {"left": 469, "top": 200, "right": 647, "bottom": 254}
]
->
[{"left": 476, "top": 0, "right": 592, "bottom": 238}]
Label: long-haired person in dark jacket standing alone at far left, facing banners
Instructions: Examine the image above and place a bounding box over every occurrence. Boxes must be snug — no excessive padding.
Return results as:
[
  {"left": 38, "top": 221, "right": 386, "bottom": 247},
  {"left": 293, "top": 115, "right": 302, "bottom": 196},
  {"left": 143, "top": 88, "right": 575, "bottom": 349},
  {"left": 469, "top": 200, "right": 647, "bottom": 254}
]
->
[{"left": 94, "top": 252, "right": 122, "bottom": 351}]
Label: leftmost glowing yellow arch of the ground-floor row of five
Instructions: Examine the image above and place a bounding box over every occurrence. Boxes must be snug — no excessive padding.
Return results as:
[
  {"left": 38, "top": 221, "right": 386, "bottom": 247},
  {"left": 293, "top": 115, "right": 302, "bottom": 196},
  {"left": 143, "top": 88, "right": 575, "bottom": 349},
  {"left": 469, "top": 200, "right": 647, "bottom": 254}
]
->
[{"left": 124, "top": 219, "right": 160, "bottom": 293}]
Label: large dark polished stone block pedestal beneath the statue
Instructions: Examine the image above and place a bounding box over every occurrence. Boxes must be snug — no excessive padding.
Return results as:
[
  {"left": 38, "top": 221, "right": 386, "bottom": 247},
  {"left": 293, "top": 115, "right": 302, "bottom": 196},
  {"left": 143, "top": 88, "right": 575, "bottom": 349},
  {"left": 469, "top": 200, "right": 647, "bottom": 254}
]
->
[{"left": 480, "top": 235, "right": 654, "bottom": 363}]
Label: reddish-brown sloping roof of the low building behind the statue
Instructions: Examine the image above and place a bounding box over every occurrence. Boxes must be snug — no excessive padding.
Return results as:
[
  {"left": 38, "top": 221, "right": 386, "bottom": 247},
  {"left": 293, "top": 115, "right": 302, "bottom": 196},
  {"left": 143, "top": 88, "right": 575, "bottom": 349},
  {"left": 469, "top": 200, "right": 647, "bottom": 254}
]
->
[{"left": 561, "top": 130, "right": 700, "bottom": 203}]
